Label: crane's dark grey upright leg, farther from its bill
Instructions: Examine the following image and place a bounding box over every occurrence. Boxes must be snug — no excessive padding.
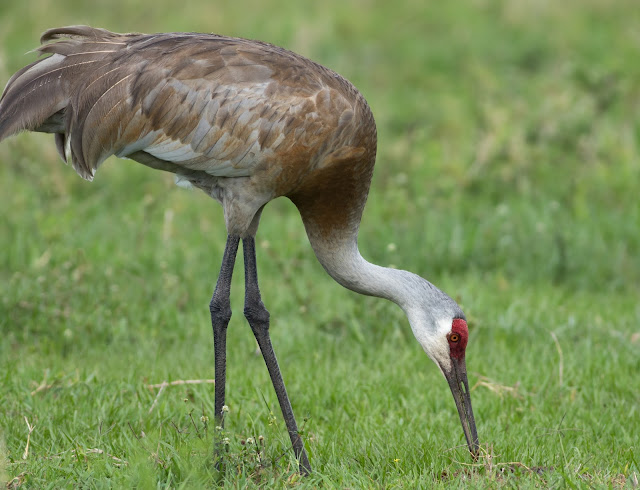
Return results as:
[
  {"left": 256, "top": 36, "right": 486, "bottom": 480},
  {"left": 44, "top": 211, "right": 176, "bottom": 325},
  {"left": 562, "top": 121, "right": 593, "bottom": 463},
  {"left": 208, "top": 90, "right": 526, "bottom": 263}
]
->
[{"left": 209, "top": 236, "right": 240, "bottom": 426}]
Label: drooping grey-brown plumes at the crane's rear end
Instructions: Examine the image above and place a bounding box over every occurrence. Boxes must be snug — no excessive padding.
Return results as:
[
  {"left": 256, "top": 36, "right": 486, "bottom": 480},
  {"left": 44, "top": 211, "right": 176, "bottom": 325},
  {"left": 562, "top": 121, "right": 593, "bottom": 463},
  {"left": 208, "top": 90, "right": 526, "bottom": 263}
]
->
[{"left": 0, "top": 26, "right": 139, "bottom": 180}]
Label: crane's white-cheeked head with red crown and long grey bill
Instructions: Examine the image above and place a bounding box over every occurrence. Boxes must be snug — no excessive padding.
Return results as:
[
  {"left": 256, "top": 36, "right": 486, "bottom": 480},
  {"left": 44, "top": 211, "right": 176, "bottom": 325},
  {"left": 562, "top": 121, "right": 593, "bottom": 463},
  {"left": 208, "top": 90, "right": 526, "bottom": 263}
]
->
[{"left": 409, "top": 308, "right": 479, "bottom": 460}]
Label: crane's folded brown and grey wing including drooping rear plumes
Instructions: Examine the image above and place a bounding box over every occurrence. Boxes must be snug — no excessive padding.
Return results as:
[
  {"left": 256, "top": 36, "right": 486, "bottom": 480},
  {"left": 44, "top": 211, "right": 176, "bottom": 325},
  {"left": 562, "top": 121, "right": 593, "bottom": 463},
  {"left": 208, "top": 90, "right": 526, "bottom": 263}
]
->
[{"left": 0, "top": 26, "right": 368, "bottom": 188}]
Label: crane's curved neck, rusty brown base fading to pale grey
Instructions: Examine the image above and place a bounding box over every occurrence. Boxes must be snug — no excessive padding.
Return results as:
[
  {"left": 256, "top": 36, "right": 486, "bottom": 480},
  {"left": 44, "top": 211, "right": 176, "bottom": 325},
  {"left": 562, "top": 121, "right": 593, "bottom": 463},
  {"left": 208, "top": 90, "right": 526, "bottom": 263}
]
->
[{"left": 288, "top": 147, "right": 430, "bottom": 313}]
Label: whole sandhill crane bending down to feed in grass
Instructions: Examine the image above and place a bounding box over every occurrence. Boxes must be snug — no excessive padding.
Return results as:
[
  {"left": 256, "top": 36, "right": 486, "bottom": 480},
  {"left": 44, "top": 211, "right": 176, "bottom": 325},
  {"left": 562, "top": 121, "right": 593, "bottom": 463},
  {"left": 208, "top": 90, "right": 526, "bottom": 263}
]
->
[{"left": 0, "top": 26, "right": 478, "bottom": 474}]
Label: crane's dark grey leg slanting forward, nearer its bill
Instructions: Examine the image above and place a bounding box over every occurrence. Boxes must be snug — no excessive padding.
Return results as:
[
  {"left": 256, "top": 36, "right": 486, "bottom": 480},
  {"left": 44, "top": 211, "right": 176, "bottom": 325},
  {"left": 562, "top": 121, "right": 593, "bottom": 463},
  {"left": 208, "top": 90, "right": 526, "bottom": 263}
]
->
[{"left": 242, "top": 237, "right": 311, "bottom": 475}]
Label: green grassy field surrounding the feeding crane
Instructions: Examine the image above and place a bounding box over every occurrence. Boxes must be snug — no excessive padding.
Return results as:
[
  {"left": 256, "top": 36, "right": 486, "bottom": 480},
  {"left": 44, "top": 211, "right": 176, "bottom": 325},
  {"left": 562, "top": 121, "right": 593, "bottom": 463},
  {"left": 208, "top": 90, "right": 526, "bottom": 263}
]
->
[{"left": 0, "top": 0, "right": 640, "bottom": 488}]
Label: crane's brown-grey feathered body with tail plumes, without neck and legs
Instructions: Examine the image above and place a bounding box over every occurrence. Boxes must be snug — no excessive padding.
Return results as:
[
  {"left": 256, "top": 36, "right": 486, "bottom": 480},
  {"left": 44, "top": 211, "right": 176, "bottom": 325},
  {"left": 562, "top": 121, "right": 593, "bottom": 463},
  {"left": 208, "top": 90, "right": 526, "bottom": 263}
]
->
[{"left": 0, "top": 28, "right": 376, "bottom": 241}]
